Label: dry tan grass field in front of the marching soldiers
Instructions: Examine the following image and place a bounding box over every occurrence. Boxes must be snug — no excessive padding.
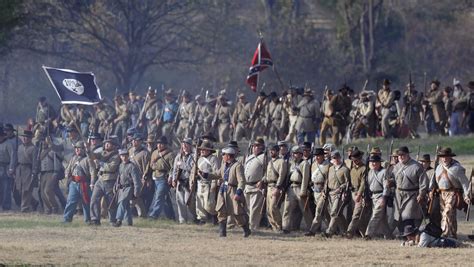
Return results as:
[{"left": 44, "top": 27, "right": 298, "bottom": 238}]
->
[{"left": 0, "top": 213, "right": 474, "bottom": 266}]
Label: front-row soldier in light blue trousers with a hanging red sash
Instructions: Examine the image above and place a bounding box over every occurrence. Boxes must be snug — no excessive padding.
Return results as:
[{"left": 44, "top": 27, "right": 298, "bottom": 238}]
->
[{"left": 64, "top": 141, "right": 95, "bottom": 223}]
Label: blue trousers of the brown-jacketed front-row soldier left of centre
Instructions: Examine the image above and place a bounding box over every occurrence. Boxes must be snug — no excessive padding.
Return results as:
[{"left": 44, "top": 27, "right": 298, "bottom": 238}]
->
[{"left": 148, "top": 178, "right": 174, "bottom": 220}]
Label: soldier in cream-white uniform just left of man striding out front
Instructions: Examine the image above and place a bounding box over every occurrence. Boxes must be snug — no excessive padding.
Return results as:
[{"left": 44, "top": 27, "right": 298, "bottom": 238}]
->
[{"left": 191, "top": 140, "right": 220, "bottom": 224}]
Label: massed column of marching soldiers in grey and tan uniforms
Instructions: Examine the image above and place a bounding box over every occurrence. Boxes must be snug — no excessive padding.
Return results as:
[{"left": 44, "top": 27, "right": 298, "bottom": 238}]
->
[{"left": 0, "top": 80, "right": 474, "bottom": 238}]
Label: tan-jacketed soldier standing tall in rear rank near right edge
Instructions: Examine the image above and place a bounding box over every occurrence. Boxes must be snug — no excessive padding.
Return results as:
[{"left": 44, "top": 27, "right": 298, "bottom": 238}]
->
[{"left": 426, "top": 80, "right": 447, "bottom": 135}]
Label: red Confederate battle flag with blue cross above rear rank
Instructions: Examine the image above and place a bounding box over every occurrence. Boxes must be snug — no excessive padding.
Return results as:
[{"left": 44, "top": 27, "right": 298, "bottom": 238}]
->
[{"left": 247, "top": 39, "right": 273, "bottom": 92}]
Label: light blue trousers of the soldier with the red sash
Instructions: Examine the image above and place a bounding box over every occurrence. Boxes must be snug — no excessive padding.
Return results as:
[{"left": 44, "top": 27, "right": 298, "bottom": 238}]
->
[{"left": 64, "top": 182, "right": 92, "bottom": 222}]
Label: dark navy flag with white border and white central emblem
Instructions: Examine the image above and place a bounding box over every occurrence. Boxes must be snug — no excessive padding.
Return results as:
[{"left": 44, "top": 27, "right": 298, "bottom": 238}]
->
[{"left": 43, "top": 66, "right": 102, "bottom": 105}]
